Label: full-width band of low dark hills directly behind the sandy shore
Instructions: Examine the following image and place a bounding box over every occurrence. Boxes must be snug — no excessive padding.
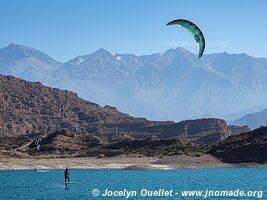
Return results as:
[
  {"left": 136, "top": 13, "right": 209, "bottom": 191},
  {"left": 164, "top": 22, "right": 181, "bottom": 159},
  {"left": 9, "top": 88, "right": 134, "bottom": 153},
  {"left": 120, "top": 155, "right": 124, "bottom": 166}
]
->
[{"left": 0, "top": 127, "right": 267, "bottom": 164}]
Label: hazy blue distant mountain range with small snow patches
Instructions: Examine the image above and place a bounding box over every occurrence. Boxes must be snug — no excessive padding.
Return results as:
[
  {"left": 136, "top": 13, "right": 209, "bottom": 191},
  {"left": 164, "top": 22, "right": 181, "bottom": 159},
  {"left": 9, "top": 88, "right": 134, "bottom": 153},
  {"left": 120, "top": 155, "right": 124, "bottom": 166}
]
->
[{"left": 0, "top": 44, "right": 267, "bottom": 124}]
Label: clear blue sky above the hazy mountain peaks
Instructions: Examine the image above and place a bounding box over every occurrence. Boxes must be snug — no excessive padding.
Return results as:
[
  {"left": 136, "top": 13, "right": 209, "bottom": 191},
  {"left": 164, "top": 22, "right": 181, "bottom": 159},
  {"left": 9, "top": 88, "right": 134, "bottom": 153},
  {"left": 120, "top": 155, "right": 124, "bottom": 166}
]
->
[{"left": 0, "top": 0, "right": 267, "bottom": 62}]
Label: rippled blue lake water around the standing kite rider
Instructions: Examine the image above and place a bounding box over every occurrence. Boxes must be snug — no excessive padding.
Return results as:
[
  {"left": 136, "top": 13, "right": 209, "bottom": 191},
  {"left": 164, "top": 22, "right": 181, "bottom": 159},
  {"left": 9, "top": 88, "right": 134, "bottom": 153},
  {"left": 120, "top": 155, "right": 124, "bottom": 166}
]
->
[{"left": 0, "top": 168, "right": 267, "bottom": 200}]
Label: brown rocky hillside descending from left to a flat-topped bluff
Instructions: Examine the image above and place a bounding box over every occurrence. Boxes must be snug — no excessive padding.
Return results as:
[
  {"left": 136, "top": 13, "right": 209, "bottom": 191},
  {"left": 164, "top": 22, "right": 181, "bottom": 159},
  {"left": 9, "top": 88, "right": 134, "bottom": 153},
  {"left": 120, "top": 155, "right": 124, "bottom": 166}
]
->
[{"left": 0, "top": 75, "right": 243, "bottom": 143}]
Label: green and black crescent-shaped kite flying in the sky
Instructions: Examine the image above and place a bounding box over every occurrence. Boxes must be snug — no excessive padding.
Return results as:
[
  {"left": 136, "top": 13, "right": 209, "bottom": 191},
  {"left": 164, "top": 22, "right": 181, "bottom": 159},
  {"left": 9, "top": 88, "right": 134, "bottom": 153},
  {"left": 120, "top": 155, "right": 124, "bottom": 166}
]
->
[{"left": 167, "top": 19, "right": 205, "bottom": 58}]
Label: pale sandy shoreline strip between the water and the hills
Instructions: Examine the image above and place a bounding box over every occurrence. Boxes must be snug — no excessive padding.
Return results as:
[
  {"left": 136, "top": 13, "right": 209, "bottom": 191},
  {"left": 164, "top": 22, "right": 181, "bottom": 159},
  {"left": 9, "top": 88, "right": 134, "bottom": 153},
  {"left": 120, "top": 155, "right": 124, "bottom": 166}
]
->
[{"left": 0, "top": 155, "right": 267, "bottom": 170}]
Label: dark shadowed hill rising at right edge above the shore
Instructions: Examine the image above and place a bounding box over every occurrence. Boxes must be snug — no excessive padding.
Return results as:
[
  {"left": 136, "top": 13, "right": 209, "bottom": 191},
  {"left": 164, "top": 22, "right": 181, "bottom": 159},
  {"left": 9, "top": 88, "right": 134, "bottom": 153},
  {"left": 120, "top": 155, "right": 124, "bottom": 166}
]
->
[{"left": 209, "top": 126, "right": 267, "bottom": 163}]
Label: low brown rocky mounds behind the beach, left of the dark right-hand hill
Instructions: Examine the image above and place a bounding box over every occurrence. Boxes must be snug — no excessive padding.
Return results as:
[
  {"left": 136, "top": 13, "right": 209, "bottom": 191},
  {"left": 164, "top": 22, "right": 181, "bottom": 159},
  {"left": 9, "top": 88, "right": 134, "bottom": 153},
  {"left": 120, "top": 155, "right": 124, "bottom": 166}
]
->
[{"left": 25, "top": 130, "right": 204, "bottom": 157}]
